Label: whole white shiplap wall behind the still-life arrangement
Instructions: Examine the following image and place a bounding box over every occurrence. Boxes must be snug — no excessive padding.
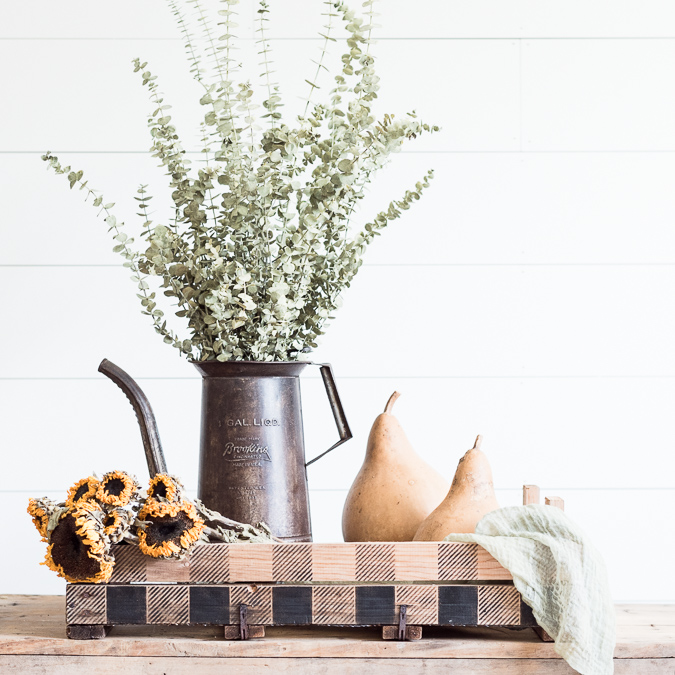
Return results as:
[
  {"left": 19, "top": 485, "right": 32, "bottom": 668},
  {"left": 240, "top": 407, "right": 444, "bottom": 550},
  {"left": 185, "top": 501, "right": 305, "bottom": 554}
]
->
[{"left": 0, "top": 0, "right": 675, "bottom": 602}]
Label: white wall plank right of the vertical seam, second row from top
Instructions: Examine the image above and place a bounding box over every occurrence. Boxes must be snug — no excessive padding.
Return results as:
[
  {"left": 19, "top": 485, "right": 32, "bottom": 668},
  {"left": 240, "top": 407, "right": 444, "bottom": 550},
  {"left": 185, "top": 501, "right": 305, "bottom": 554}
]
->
[{"left": 522, "top": 40, "right": 675, "bottom": 150}]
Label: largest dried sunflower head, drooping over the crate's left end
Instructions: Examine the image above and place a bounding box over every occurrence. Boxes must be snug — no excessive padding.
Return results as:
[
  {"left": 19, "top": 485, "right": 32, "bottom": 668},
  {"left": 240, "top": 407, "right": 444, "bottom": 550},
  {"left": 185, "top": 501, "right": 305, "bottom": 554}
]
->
[{"left": 43, "top": 502, "right": 114, "bottom": 584}]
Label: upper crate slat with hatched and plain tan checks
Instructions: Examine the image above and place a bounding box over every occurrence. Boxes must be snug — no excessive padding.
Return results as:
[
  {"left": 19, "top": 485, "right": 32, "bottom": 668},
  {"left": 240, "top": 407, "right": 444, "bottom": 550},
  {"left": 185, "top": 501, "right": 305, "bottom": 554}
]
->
[{"left": 112, "top": 541, "right": 511, "bottom": 584}]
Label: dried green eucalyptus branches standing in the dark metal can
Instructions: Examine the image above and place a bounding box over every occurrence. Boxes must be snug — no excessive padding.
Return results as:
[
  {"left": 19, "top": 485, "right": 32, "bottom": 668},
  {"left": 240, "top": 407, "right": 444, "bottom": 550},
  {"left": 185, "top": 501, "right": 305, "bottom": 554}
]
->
[{"left": 43, "top": 0, "right": 438, "bottom": 361}]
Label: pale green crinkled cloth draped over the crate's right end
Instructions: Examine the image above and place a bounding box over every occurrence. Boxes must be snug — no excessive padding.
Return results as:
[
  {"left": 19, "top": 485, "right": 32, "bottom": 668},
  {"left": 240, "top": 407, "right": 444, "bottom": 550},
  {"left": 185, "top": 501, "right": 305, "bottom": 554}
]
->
[{"left": 445, "top": 504, "right": 616, "bottom": 675}]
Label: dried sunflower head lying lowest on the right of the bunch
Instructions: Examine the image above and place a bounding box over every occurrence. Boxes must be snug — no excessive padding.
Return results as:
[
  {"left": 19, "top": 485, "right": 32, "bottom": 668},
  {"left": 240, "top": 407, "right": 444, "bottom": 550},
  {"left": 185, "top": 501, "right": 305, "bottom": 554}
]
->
[{"left": 138, "top": 500, "right": 204, "bottom": 558}]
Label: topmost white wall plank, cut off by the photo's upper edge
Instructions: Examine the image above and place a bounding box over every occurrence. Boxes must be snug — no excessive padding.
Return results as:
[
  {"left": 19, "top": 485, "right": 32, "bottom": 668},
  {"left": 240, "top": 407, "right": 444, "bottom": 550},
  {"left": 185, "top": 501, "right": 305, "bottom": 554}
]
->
[{"left": 0, "top": 0, "right": 675, "bottom": 38}]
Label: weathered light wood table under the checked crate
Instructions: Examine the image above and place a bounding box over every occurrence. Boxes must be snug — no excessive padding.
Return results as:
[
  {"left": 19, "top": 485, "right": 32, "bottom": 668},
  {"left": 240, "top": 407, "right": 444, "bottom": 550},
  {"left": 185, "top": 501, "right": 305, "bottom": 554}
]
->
[{"left": 0, "top": 595, "right": 675, "bottom": 675}]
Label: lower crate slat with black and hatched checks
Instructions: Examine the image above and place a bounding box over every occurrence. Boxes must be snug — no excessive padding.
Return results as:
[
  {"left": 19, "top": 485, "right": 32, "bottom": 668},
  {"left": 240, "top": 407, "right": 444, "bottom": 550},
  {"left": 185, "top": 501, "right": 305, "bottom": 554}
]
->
[{"left": 66, "top": 583, "right": 536, "bottom": 626}]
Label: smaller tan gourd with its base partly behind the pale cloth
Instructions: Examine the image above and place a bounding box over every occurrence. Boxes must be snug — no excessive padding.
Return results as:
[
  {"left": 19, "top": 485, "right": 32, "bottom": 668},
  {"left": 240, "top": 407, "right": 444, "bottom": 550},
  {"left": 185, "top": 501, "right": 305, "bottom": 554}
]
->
[{"left": 415, "top": 436, "right": 499, "bottom": 541}]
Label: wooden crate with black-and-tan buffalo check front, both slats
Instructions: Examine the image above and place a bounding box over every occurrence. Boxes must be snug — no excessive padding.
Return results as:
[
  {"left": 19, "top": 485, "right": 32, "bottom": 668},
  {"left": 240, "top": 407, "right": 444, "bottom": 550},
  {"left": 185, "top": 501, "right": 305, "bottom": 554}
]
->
[{"left": 66, "top": 542, "right": 536, "bottom": 636}]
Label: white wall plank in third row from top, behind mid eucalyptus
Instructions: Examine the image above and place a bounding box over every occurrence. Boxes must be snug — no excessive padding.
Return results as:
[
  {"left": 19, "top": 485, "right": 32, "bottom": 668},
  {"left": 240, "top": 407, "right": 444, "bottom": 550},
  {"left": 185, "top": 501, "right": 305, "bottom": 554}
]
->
[{"left": 6, "top": 153, "right": 675, "bottom": 266}]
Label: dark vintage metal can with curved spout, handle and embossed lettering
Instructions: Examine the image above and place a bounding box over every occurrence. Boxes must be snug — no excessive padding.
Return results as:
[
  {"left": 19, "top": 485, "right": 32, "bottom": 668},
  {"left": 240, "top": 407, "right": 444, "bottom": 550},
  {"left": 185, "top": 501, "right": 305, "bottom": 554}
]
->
[{"left": 99, "top": 359, "right": 352, "bottom": 541}]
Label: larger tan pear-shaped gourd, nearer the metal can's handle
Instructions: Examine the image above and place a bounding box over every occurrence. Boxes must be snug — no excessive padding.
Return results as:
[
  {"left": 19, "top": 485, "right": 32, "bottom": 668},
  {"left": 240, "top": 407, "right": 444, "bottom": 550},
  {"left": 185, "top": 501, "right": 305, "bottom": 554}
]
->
[{"left": 342, "top": 391, "right": 448, "bottom": 541}]
